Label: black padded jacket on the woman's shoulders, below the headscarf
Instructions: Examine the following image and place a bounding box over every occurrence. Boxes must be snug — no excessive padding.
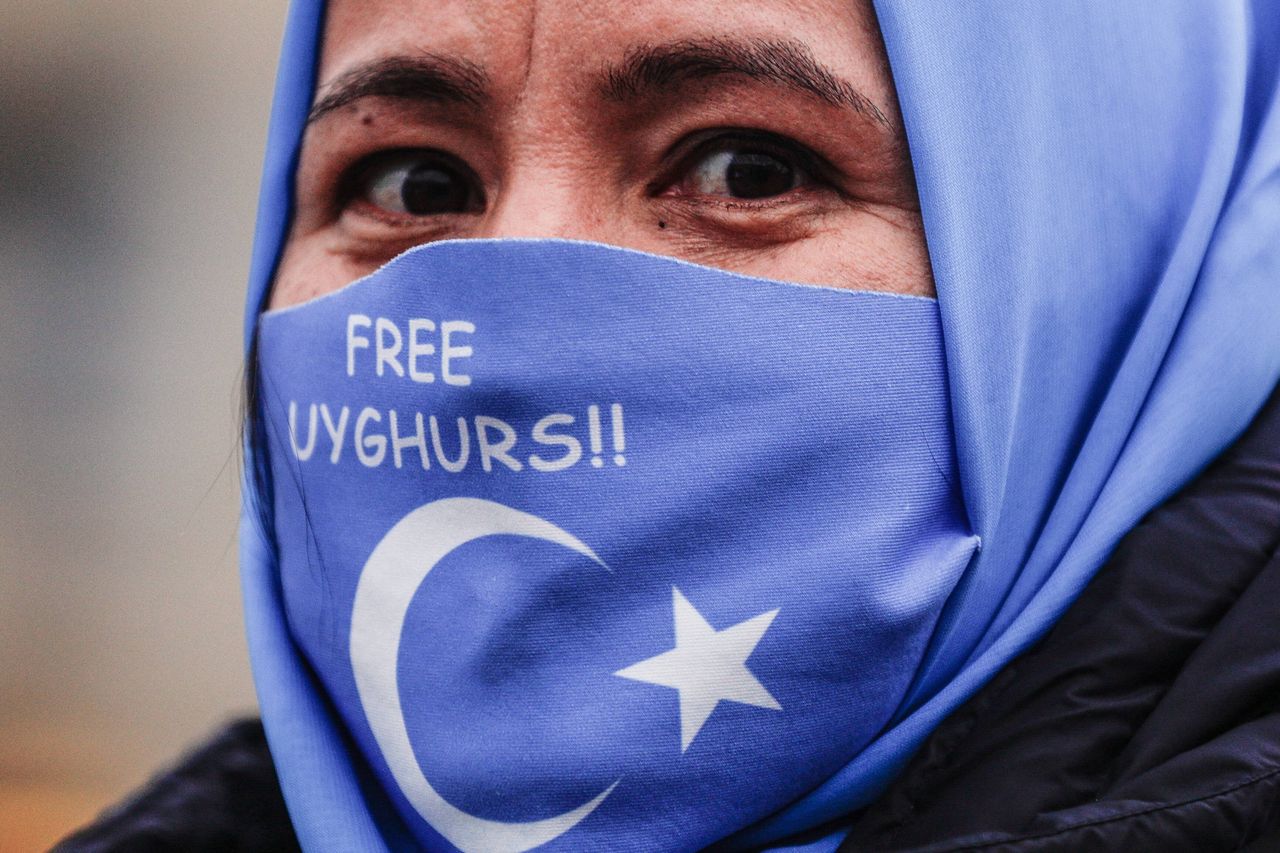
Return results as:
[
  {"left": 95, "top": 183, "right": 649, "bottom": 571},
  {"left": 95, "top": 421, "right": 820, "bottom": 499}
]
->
[{"left": 56, "top": 391, "right": 1280, "bottom": 853}]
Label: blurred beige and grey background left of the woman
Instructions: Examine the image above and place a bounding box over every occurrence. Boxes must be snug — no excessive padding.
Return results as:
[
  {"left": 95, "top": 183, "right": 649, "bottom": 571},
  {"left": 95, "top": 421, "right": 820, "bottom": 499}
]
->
[{"left": 0, "top": 0, "right": 285, "bottom": 853}]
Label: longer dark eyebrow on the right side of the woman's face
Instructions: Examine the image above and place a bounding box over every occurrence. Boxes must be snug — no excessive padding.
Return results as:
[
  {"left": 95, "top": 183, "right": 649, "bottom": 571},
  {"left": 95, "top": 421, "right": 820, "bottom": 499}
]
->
[{"left": 602, "top": 38, "right": 892, "bottom": 129}]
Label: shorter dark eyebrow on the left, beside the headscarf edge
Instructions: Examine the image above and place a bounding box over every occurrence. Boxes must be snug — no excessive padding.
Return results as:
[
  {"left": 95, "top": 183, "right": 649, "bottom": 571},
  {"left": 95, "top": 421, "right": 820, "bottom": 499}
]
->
[{"left": 307, "top": 54, "right": 489, "bottom": 124}]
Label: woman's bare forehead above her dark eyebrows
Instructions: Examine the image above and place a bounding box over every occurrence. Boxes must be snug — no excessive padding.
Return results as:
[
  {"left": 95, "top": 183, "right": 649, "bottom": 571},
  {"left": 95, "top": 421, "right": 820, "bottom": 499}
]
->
[{"left": 320, "top": 0, "right": 892, "bottom": 104}]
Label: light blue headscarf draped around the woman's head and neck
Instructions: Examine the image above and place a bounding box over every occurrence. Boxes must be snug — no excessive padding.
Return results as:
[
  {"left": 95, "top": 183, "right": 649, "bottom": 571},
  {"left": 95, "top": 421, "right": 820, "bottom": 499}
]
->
[{"left": 241, "top": 0, "right": 1280, "bottom": 850}]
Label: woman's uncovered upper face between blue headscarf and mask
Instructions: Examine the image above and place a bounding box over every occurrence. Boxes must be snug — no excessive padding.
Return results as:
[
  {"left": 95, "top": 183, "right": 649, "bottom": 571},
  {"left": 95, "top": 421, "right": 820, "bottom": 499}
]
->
[{"left": 271, "top": 0, "right": 933, "bottom": 307}]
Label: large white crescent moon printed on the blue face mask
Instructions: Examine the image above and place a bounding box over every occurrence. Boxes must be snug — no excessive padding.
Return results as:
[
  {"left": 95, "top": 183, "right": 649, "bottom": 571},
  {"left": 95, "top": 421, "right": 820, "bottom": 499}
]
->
[{"left": 351, "top": 498, "right": 621, "bottom": 853}]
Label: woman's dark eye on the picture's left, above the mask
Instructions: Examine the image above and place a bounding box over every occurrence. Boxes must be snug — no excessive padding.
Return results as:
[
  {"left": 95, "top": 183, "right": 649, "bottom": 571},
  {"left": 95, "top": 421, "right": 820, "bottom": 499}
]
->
[{"left": 352, "top": 151, "right": 484, "bottom": 216}]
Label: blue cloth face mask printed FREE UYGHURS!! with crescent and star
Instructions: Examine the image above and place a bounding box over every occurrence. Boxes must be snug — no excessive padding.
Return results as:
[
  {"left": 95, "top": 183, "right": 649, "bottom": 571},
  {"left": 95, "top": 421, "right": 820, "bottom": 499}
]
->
[{"left": 260, "top": 241, "right": 977, "bottom": 852}]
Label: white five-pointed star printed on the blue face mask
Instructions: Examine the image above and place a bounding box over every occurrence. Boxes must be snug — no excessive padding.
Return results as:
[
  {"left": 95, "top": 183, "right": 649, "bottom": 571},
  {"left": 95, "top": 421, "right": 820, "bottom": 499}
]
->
[{"left": 614, "top": 587, "right": 782, "bottom": 752}]
